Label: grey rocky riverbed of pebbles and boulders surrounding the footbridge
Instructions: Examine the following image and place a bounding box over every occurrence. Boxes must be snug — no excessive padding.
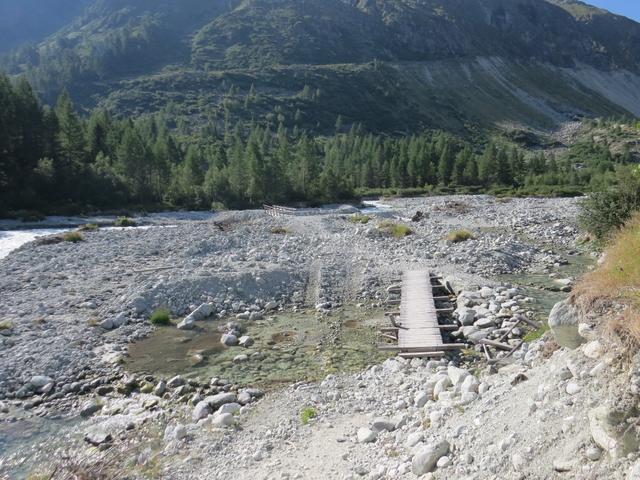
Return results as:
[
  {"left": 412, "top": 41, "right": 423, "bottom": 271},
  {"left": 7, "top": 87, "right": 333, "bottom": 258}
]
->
[{"left": 0, "top": 196, "right": 624, "bottom": 479}]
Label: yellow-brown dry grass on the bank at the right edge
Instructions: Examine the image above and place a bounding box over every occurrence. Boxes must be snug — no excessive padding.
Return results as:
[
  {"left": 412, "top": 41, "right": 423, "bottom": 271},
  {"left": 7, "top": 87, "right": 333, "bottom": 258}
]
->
[{"left": 574, "top": 213, "right": 640, "bottom": 348}]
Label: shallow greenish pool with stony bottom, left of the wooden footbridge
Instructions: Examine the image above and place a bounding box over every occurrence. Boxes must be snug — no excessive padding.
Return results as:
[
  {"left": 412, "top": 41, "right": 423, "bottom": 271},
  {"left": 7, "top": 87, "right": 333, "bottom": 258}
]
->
[{"left": 126, "top": 307, "right": 389, "bottom": 388}]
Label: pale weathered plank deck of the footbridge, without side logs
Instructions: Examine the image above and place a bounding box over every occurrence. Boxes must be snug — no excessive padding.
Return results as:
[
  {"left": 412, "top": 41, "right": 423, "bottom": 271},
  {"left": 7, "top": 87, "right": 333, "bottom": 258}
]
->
[{"left": 398, "top": 270, "right": 444, "bottom": 356}]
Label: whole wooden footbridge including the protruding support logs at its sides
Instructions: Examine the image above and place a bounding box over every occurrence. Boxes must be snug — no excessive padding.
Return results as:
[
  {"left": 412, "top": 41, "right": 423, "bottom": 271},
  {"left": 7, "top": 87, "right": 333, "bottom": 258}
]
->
[{"left": 379, "top": 270, "right": 466, "bottom": 358}]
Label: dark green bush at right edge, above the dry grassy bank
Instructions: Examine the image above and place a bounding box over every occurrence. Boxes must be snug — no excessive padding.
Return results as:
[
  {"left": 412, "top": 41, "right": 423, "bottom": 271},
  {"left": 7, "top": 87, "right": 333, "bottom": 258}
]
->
[{"left": 580, "top": 166, "right": 640, "bottom": 240}]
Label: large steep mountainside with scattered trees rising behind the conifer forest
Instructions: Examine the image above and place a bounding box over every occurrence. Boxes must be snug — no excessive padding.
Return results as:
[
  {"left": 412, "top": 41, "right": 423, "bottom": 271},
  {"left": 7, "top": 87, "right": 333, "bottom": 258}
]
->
[{"left": 4, "top": 0, "right": 640, "bottom": 132}]
